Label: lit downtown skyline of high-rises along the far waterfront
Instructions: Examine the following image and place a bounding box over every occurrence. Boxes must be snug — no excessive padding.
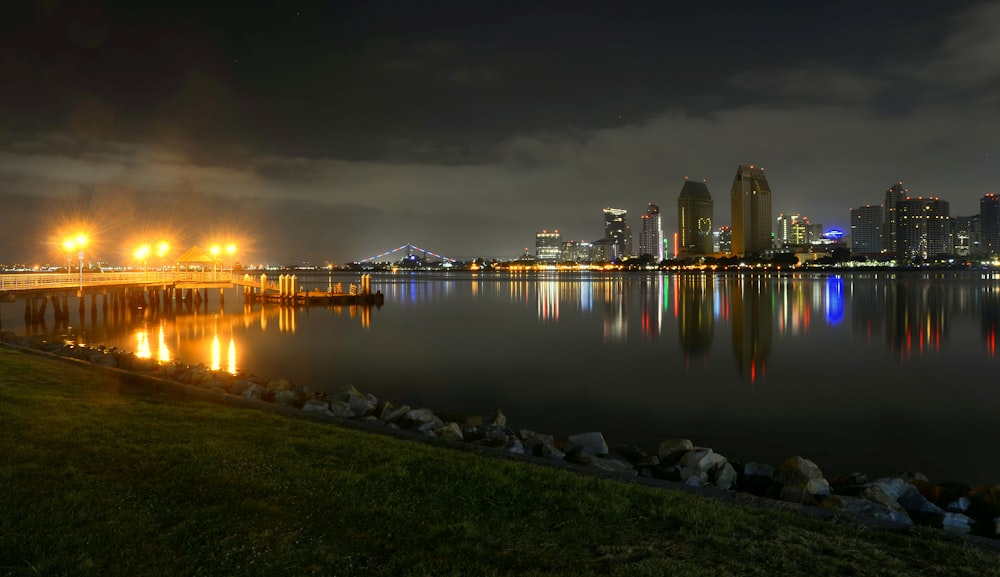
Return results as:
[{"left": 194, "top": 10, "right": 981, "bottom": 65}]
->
[{"left": 524, "top": 164, "right": 1000, "bottom": 265}]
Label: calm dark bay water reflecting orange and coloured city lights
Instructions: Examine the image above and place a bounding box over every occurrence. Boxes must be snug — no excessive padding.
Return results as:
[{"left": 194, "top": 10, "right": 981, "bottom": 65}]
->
[{"left": 0, "top": 273, "right": 1000, "bottom": 483}]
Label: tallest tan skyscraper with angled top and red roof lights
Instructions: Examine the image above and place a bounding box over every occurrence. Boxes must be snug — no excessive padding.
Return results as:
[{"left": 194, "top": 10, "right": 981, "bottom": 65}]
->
[{"left": 730, "top": 164, "right": 771, "bottom": 256}]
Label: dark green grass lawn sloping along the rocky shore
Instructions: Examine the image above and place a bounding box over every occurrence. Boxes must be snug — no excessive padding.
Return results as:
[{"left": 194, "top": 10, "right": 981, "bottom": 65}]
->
[{"left": 0, "top": 348, "right": 1000, "bottom": 577}]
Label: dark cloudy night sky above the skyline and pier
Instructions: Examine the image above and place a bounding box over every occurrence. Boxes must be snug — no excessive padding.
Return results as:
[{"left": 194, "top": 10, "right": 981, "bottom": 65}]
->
[{"left": 0, "top": 0, "right": 1000, "bottom": 264}]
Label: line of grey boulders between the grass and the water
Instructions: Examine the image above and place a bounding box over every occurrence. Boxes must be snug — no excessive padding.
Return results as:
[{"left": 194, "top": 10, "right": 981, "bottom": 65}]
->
[{"left": 7, "top": 331, "right": 1000, "bottom": 539}]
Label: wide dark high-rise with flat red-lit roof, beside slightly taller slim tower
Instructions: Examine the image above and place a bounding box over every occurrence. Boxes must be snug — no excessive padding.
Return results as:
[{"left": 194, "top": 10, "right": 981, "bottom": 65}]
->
[{"left": 896, "top": 197, "right": 952, "bottom": 262}]
